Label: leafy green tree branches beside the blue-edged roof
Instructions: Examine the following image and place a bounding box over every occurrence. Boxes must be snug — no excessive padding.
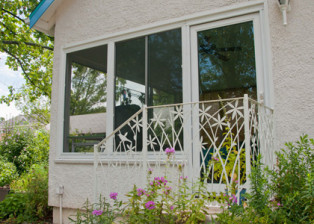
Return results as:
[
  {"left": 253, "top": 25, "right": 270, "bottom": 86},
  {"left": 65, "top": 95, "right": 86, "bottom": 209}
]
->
[{"left": 0, "top": 0, "right": 53, "bottom": 104}]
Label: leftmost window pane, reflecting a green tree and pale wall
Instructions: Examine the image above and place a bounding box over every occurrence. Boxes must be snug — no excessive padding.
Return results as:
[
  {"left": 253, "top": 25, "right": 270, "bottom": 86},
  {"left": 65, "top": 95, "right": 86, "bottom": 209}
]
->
[{"left": 64, "top": 46, "right": 107, "bottom": 152}]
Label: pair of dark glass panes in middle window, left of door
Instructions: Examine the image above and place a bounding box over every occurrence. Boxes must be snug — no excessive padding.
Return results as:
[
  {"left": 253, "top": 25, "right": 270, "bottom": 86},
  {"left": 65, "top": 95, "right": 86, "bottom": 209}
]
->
[{"left": 115, "top": 29, "right": 183, "bottom": 151}]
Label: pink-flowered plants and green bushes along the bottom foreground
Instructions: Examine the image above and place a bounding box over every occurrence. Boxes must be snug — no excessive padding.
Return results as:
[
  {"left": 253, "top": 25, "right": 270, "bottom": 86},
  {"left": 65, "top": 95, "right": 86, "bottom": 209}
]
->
[{"left": 70, "top": 135, "right": 314, "bottom": 224}]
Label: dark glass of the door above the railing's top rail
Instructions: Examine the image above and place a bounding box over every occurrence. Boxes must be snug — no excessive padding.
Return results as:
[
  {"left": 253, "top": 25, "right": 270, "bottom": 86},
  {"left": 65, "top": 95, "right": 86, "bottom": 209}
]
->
[{"left": 198, "top": 21, "right": 256, "bottom": 100}]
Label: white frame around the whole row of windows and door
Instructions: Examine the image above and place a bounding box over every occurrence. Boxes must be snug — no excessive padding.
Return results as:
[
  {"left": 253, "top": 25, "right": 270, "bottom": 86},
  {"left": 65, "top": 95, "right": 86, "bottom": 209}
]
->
[{"left": 54, "top": 0, "right": 273, "bottom": 164}]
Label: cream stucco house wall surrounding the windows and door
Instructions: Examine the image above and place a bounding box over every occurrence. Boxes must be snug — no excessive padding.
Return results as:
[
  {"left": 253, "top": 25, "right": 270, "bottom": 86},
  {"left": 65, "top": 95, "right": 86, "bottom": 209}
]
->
[{"left": 49, "top": 0, "right": 314, "bottom": 223}]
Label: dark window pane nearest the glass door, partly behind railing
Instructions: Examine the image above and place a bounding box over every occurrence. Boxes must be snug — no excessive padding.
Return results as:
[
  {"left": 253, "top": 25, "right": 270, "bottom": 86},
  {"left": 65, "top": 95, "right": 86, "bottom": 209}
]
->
[{"left": 147, "top": 29, "right": 183, "bottom": 151}]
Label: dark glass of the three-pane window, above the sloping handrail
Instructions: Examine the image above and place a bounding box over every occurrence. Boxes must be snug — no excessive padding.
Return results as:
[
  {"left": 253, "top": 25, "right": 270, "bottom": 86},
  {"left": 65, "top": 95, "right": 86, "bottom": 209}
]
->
[{"left": 64, "top": 29, "right": 182, "bottom": 152}]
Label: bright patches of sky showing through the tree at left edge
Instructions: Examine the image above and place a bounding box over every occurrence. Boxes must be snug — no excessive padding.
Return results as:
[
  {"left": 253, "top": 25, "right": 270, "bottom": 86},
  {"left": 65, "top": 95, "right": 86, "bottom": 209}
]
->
[{"left": 0, "top": 53, "right": 24, "bottom": 119}]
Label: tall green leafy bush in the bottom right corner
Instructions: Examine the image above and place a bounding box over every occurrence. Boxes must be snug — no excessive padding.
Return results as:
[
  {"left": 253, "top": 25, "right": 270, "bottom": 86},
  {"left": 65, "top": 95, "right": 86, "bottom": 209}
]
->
[{"left": 216, "top": 135, "right": 314, "bottom": 223}]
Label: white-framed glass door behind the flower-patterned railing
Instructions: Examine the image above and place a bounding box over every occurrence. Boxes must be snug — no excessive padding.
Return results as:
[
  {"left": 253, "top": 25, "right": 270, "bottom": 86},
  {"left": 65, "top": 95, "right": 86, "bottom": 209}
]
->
[{"left": 191, "top": 15, "right": 263, "bottom": 190}]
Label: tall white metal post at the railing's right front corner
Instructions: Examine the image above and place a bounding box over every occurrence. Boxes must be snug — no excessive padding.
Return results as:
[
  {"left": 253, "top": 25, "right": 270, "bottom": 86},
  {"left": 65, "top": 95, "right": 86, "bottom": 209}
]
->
[{"left": 243, "top": 94, "right": 251, "bottom": 187}]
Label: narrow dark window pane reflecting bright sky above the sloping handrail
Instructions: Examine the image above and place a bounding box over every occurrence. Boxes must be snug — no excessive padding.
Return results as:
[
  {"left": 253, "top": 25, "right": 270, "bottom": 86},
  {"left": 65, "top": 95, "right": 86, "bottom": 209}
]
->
[{"left": 115, "top": 37, "right": 145, "bottom": 128}]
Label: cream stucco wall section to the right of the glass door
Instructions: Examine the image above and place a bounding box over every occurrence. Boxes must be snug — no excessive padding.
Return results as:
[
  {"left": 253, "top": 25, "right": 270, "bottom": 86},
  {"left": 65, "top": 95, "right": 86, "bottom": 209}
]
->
[{"left": 268, "top": 0, "right": 314, "bottom": 144}]
